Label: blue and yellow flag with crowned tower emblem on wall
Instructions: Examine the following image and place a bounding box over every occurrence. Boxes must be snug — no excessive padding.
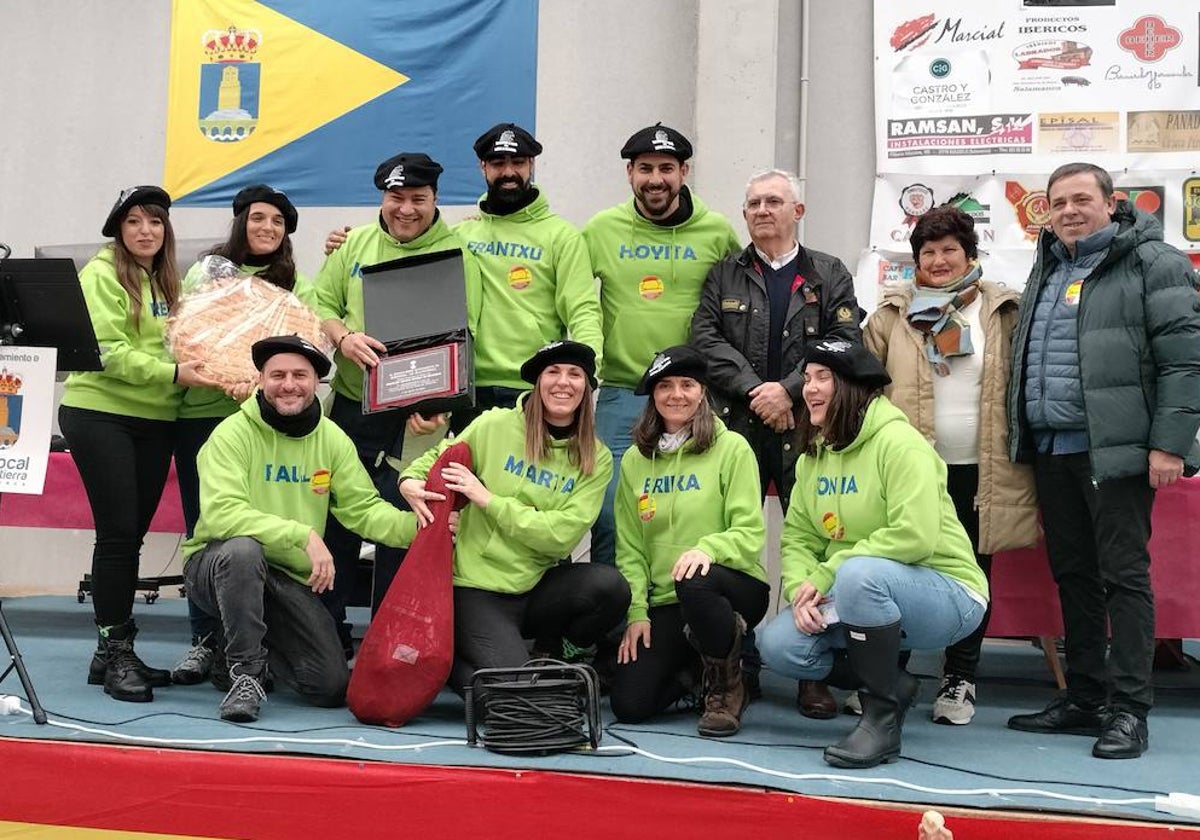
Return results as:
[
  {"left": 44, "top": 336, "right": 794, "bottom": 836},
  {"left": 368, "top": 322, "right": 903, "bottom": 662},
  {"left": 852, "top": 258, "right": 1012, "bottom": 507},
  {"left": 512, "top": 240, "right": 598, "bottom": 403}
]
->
[{"left": 163, "top": 0, "right": 538, "bottom": 206}]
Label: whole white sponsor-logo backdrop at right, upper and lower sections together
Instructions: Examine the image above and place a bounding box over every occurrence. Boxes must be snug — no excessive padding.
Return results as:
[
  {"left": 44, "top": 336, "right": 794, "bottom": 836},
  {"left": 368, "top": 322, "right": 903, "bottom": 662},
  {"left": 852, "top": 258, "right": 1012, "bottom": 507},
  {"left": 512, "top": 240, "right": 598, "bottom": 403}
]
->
[{"left": 860, "top": 0, "right": 1200, "bottom": 258}]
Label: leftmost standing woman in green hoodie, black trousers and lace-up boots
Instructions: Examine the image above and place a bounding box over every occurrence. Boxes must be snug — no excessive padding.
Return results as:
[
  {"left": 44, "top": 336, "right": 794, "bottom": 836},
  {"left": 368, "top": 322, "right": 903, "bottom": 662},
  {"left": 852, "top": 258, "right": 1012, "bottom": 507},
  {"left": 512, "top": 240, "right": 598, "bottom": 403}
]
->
[{"left": 59, "top": 186, "right": 216, "bottom": 702}]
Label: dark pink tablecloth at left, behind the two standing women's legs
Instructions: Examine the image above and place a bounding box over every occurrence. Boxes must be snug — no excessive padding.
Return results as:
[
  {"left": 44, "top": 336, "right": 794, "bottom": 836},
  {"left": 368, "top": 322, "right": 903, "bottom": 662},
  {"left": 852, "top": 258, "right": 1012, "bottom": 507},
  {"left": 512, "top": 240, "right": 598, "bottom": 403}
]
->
[{"left": 0, "top": 452, "right": 184, "bottom": 534}]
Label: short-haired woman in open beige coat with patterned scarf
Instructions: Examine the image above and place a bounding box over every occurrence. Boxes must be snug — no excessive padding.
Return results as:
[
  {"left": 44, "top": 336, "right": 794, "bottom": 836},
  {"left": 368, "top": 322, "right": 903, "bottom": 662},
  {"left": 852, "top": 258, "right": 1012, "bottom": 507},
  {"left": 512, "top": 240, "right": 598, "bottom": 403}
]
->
[{"left": 863, "top": 205, "right": 1038, "bottom": 725}]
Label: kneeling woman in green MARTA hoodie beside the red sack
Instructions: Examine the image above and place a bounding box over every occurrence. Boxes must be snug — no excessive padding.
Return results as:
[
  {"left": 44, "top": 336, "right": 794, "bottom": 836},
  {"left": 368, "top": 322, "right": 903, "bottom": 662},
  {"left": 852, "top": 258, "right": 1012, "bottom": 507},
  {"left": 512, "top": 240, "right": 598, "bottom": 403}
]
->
[{"left": 400, "top": 341, "right": 629, "bottom": 692}]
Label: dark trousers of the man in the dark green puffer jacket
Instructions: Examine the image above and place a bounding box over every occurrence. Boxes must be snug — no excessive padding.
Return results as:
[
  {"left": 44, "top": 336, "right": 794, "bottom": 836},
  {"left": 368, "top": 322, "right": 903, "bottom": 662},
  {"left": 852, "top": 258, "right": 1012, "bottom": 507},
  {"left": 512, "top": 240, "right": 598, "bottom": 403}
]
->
[{"left": 1033, "top": 452, "right": 1154, "bottom": 718}]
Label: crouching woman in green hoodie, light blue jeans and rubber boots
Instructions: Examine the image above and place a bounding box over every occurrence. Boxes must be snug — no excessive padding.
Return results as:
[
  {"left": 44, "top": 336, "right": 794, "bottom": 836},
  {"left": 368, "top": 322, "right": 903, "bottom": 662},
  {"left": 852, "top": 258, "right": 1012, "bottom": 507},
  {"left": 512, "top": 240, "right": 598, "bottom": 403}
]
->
[{"left": 760, "top": 340, "right": 988, "bottom": 767}]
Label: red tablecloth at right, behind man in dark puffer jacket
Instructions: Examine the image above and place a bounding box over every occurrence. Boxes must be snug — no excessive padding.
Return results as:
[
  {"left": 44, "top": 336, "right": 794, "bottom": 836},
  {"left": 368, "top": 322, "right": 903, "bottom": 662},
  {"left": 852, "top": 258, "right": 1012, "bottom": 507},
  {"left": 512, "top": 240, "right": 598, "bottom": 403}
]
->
[{"left": 988, "top": 478, "right": 1200, "bottom": 638}]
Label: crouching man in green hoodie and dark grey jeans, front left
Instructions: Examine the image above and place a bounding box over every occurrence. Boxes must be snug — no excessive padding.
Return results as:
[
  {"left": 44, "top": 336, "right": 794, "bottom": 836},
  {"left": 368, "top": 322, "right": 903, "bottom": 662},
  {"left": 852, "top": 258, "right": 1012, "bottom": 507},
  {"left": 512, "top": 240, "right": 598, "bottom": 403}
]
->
[{"left": 184, "top": 336, "right": 429, "bottom": 722}]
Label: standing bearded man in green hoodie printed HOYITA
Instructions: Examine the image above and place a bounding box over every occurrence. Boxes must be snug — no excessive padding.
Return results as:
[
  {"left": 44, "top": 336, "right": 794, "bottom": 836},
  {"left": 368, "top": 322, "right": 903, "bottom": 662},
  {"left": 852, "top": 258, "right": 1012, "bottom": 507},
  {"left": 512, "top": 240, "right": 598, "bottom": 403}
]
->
[{"left": 583, "top": 122, "right": 739, "bottom": 565}]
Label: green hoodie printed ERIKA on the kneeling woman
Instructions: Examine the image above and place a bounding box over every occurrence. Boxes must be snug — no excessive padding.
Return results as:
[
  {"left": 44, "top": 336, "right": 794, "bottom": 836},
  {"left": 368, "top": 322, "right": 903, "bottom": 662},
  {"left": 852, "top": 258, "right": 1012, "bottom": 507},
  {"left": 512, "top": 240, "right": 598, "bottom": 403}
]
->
[{"left": 616, "top": 418, "right": 767, "bottom": 622}]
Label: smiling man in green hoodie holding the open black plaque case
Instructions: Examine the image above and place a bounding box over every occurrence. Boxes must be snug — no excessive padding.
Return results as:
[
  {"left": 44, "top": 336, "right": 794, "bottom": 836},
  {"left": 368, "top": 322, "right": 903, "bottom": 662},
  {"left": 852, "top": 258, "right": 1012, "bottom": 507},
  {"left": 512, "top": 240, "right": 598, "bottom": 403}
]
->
[{"left": 314, "top": 152, "right": 480, "bottom": 656}]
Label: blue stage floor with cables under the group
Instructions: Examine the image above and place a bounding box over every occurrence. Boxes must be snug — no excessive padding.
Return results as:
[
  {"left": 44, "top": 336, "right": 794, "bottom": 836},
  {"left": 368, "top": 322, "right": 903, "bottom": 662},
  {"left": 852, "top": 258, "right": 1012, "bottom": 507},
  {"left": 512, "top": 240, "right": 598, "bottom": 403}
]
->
[{"left": 0, "top": 596, "right": 1200, "bottom": 824}]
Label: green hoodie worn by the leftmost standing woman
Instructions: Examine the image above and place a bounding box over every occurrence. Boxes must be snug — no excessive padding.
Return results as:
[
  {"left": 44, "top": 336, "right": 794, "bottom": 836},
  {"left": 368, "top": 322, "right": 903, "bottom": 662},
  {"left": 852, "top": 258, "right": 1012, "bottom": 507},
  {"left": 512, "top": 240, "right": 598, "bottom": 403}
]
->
[{"left": 62, "top": 245, "right": 182, "bottom": 420}]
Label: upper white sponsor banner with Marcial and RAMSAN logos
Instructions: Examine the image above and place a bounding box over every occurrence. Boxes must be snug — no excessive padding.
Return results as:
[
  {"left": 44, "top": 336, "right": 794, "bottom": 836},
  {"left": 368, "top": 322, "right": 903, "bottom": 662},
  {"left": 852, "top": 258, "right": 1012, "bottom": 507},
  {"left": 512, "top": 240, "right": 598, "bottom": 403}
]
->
[{"left": 875, "top": 0, "right": 1200, "bottom": 175}]
